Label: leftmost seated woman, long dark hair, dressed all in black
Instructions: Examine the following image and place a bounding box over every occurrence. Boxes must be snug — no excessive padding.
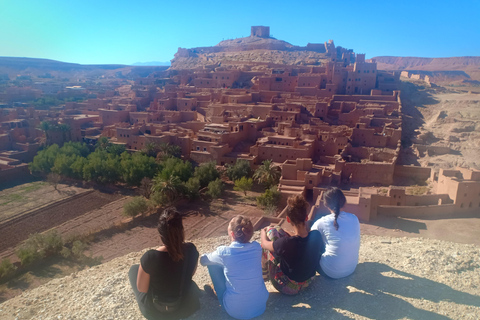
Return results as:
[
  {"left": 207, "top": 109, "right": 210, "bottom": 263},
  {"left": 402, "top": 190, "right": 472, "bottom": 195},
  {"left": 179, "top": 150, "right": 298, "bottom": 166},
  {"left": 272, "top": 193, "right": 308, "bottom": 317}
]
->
[{"left": 128, "top": 209, "right": 200, "bottom": 319}]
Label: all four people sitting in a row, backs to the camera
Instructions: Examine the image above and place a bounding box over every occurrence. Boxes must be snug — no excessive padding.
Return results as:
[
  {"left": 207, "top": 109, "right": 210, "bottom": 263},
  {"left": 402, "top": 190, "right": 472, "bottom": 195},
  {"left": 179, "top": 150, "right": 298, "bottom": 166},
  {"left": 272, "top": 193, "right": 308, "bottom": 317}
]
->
[{"left": 129, "top": 188, "right": 360, "bottom": 319}]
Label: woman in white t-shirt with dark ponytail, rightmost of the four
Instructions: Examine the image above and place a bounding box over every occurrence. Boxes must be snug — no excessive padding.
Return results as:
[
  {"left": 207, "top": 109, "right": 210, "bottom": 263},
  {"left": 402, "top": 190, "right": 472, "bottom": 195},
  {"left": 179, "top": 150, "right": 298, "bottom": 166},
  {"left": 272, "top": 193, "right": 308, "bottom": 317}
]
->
[{"left": 311, "top": 187, "right": 360, "bottom": 279}]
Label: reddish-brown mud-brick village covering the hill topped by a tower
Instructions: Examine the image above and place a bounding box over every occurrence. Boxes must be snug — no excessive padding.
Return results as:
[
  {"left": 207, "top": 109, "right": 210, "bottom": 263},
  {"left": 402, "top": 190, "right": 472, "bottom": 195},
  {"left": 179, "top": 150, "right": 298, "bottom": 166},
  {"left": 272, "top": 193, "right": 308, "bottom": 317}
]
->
[{"left": 0, "top": 26, "right": 480, "bottom": 221}]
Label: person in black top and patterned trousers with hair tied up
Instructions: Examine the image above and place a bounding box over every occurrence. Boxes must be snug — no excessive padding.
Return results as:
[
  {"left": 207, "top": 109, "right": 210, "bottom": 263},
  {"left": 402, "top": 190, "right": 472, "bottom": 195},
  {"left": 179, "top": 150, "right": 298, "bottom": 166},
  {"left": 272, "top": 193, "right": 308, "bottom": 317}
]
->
[{"left": 261, "top": 195, "right": 323, "bottom": 295}]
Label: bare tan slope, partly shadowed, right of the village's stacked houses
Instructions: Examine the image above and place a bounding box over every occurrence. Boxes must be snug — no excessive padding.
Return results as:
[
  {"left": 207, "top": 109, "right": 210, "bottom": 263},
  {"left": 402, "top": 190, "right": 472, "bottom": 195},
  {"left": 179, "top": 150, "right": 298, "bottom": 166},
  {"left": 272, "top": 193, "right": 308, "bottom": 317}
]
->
[{"left": 400, "top": 81, "right": 480, "bottom": 169}]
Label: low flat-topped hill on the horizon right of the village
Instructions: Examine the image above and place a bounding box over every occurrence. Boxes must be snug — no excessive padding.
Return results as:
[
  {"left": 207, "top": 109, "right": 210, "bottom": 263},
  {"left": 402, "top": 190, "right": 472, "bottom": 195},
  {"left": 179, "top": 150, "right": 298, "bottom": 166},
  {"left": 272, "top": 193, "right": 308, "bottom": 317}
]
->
[{"left": 373, "top": 56, "right": 480, "bottom": 80}]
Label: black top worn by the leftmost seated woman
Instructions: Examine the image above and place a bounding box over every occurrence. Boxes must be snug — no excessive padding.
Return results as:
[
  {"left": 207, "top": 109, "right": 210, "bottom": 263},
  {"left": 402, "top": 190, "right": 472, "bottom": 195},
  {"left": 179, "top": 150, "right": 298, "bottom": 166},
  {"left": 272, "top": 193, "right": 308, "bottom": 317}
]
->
[{"left": 140, "top": 243, "right": 198, "bottom": 302}]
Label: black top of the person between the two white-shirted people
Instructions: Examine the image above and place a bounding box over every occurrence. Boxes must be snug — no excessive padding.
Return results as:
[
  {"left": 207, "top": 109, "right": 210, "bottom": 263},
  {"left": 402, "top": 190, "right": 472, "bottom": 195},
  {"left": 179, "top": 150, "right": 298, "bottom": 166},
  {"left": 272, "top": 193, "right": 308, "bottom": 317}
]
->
[{"left": 273, "top": 230, "right": 323, "bottom": 282}]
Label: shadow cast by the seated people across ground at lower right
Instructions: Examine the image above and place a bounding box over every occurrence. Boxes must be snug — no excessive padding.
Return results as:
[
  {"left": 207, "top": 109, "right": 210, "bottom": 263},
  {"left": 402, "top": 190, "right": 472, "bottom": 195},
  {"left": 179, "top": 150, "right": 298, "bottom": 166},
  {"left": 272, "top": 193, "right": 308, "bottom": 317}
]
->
[{"left": 265, "top": 262, "right": 480, "bottom": 320}]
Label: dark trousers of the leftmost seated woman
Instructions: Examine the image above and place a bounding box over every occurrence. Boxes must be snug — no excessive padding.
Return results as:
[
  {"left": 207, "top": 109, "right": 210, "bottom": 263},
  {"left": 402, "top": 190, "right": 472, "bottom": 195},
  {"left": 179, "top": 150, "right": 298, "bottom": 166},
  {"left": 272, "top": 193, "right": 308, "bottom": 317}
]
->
[{"left": 128, "top": 264, "right": 200, "bottom": 320}]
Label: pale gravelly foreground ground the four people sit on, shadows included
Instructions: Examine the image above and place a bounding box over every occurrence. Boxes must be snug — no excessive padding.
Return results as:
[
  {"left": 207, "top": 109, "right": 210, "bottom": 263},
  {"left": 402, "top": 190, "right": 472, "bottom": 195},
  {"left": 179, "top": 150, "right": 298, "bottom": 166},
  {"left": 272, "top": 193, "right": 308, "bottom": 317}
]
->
[{"left": 0, "top": 234, "right": 480, "bottom": 319}]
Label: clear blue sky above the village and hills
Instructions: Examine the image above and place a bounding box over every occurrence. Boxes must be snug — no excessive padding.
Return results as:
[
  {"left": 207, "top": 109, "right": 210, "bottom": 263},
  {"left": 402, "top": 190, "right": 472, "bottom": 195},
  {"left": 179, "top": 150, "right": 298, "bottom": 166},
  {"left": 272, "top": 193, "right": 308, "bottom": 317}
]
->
[{"left": 0, "top": 0, "right": 480, "bottom": 64}]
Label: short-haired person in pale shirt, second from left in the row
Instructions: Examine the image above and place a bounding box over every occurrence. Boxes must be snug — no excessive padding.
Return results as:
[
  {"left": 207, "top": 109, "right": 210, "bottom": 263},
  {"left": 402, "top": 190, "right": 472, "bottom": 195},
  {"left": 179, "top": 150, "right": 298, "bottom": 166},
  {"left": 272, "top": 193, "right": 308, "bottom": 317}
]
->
[{"left": 200, "top": 216, "right": 268, "bottom": 319}]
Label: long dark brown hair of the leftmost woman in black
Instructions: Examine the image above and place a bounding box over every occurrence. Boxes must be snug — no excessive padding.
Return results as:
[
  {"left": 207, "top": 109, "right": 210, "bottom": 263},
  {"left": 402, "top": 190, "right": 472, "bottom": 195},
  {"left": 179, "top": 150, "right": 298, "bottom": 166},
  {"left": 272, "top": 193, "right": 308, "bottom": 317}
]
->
[{"left": 157, "top": 208, "right": 185, "bottom": 261}]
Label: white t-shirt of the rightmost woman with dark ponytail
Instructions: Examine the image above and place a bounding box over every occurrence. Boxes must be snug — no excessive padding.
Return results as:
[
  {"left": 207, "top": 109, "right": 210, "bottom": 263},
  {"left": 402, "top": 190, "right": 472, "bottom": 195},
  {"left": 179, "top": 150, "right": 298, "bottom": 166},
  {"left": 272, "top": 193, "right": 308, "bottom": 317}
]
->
[{"left": 312, "top": 211, "right": 360, "bottom": 279}]
